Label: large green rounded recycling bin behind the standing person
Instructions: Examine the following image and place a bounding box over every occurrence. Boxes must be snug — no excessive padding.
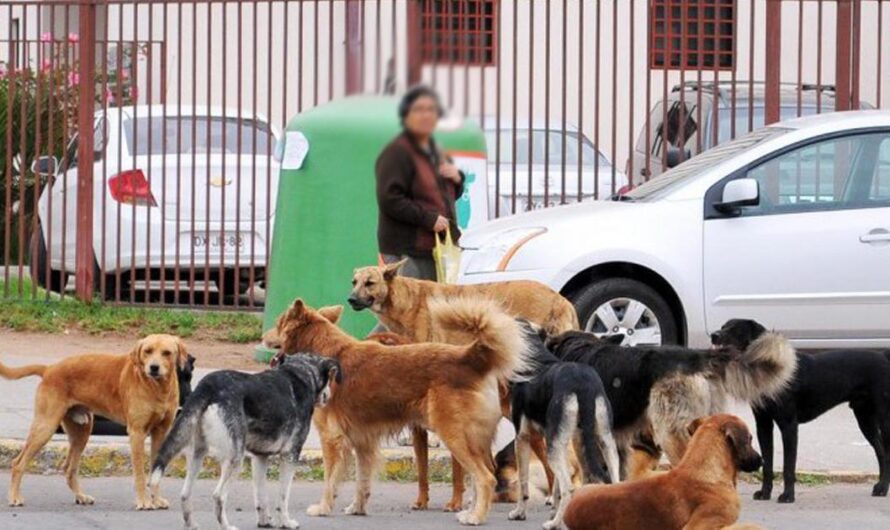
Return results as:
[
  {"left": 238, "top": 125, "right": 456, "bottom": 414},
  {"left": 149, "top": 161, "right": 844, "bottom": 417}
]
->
[{"left": 257, "top": 96, "right": 489, "bottom": 360}]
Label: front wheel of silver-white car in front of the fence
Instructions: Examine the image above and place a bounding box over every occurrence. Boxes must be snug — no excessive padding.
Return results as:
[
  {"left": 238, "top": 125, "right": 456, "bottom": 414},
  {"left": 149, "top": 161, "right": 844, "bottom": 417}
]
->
[{"left": 572, "top": 278, "right": 679, "bottom": 346}]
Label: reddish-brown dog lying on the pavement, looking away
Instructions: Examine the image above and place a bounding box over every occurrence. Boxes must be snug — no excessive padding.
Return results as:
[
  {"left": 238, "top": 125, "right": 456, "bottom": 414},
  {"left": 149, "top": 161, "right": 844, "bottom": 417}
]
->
[{"left": 564, "top": 414, "right": 761, "bottom": 530}]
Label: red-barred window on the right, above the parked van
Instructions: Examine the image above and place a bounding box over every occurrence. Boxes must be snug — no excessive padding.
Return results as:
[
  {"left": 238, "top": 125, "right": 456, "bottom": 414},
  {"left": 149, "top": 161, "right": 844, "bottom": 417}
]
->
[{"left": 649, "top": 0, "right": 736, "bottom": 70}]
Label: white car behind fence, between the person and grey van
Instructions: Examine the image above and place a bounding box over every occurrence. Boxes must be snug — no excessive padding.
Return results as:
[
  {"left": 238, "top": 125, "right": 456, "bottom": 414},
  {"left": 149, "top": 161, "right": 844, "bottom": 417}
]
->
[{"left": 476, "top": 116, "right": 627, "bottom": 217}]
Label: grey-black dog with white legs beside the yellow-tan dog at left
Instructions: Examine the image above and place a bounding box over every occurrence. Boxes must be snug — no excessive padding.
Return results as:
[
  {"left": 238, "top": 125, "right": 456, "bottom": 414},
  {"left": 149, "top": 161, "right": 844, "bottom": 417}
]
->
[{"left": 151, "top": 354, "right": 342, "bottom": 529}]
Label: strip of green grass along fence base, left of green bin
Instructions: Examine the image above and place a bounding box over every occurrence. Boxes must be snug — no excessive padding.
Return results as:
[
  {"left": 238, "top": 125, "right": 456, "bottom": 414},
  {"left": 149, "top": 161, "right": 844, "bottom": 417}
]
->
[{"left": 0, "top": 279, "right": 262, "bottom": 344}]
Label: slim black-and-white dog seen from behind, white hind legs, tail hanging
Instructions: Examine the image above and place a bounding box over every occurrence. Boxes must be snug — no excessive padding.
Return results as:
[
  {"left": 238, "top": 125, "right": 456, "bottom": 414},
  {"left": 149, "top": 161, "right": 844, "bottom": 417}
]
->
[{"left": 509, "top": 322, "right": 619, "bottom": 529}]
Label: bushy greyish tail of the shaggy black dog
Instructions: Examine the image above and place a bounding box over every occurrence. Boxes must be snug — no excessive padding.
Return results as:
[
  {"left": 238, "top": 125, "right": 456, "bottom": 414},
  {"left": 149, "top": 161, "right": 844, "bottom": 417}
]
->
[{"left": 723, "top": 332, "right": 797, "bottom": 405}]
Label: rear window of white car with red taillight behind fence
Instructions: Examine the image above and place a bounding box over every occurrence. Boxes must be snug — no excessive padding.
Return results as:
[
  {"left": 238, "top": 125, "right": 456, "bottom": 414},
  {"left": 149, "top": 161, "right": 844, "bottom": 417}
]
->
[{"left": 124, "top": 116, "right": 274, "bottom": 155}]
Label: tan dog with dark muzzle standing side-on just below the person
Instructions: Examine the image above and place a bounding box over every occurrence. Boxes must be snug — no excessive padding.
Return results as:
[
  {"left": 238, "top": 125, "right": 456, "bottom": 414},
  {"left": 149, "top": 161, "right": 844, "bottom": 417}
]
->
[{"left": 348, "top": 260, "right": 579, "bottom": 511}]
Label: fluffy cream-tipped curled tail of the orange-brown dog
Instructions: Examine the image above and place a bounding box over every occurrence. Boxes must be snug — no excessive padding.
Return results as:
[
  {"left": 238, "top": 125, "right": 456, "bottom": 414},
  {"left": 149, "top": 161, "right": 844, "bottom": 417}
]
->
[{"left": 428, "top": 297, "right": 533, "bottom": 380}]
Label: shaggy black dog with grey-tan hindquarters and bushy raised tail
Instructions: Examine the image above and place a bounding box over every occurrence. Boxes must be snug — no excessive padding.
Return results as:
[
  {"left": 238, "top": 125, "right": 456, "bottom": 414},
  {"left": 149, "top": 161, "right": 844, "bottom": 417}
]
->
[{"left": 548, "top": 331, "right": 796, "bottom": 472}]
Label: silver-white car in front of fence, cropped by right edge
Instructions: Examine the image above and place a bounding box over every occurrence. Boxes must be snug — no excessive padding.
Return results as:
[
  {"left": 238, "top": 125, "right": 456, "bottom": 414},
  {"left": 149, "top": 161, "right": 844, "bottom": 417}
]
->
[{"left": 461, "top": 111, "right": 890, "bottom": 348}]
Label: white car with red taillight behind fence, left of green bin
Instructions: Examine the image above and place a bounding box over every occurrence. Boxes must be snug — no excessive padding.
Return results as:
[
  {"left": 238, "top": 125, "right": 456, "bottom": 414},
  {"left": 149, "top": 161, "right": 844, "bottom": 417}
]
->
[{"left": 31, "top": 105, "right": 279, "bottom": 297}]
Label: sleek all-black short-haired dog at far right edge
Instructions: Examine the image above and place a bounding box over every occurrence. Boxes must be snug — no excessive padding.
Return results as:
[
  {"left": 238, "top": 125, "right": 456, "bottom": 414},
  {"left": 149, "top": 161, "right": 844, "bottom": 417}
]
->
[{"left": 711, "top": 319, "right": 890, "bottom": 503}]
